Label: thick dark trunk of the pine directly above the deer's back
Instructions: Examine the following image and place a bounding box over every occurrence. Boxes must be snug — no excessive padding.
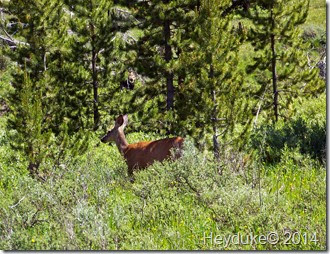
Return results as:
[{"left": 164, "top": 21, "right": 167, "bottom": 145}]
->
[{"left": 164, "top": 16, "right": 174, "bottom": 110}]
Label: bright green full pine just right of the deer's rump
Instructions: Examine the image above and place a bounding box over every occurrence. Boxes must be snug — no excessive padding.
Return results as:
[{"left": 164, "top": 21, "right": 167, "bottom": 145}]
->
[{"left": 179, "top": 0, "right": 249, "bottom": 159}]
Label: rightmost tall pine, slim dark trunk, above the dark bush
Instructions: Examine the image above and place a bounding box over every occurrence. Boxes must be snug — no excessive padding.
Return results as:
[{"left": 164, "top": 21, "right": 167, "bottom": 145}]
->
[{"left": 248, "top": 0, "right": 324, "bottom": 122}]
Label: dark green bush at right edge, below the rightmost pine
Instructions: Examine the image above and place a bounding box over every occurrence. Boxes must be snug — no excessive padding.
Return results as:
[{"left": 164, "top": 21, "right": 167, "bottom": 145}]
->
[{"left": 251, "top": 95, "right": 326, "bottom": 163}]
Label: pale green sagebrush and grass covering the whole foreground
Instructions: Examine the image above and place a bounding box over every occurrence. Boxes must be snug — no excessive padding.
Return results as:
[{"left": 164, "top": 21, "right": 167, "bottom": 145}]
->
[{"left": 0, "top": 134, "right": 326, "bottom": 250}]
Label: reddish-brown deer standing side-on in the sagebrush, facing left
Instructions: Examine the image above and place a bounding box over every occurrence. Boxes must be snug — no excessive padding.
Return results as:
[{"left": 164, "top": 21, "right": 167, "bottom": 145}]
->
[{"left": 101, "top": 115, "right": 184, "bottom": 177}]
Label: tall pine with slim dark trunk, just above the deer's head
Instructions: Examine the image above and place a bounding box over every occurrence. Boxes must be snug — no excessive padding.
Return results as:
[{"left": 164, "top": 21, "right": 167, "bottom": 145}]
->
[{"left": 63, "top": 0, "right": 137, "bottom": 130}]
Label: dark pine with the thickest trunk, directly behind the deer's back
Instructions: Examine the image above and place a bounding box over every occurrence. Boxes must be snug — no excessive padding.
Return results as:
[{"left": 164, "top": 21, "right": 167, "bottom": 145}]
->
[{"left": 132, "top": 0, "right": 199, "bottom": 134}]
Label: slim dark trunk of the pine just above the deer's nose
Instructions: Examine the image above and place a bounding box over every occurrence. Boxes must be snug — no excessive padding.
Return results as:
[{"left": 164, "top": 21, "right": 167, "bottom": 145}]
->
[{"left": 91, "top": 23, "right": 100, "bottom": 130}]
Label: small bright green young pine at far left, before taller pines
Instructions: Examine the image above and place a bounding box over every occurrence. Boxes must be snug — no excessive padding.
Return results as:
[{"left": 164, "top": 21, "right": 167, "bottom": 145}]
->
[{"left": 6, "top": 72, "right": 88, "bottom": 180}]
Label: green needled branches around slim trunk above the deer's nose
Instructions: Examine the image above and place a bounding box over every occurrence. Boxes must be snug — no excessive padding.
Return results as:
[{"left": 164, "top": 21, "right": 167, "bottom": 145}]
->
[{"left": 55, "top": 0, "right": 123, "bottom": 130}]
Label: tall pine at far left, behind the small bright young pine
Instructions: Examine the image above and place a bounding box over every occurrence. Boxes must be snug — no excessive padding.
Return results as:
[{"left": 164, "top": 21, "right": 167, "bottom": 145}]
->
[{"left": 5, "top": 0, "right": 65, "bottom": 134}]
